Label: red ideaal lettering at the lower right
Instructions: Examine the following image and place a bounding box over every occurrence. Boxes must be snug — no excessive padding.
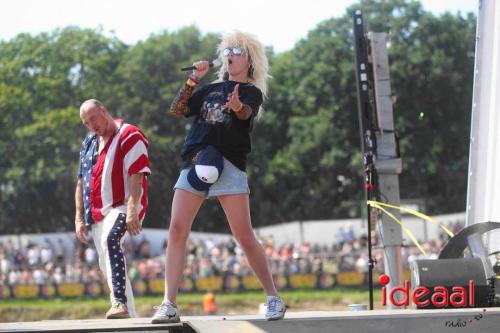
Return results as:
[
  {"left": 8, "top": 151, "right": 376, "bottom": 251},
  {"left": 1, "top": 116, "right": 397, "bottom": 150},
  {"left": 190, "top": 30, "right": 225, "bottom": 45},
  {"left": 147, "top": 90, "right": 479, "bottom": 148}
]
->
[{"left": 378, "top": 274, "right": 474, "bottom": 308}]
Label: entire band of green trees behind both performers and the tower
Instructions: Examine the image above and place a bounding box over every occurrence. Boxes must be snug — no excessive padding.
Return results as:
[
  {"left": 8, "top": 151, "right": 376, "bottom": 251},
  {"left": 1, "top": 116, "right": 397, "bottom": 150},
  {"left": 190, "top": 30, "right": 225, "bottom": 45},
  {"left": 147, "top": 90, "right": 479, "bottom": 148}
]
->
[{"left": 0, "top": 0, "right": 475, "bottom": 233}]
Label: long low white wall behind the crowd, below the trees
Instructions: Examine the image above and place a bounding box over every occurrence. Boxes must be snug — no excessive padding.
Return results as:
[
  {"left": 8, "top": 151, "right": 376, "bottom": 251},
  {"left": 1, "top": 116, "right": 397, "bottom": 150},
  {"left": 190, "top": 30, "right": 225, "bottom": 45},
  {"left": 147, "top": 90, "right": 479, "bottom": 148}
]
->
[{"left": 0, "top": 212, "right": 465, "bottom": 254}]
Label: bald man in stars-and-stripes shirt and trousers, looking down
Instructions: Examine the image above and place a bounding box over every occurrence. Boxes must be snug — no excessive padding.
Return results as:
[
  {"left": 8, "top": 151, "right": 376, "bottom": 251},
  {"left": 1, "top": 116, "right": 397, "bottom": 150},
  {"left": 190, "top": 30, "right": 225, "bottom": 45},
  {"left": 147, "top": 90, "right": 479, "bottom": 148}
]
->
[{"left": 75, "top": 99, "right": 151, "bottom": 319}]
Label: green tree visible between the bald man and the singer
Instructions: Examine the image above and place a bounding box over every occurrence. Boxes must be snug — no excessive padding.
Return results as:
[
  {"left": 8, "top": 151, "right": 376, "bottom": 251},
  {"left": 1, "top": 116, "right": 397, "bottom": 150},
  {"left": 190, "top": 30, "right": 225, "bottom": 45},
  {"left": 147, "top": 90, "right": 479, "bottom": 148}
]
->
[{"left": 112, "top": 27, "right": 222, "bottom": 230}]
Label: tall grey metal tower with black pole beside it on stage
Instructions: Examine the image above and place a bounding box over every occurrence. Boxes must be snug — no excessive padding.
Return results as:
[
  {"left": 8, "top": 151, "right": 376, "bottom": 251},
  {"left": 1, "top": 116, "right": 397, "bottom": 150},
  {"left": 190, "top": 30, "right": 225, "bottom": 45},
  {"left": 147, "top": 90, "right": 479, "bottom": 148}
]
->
[{"left": 353, "top": 11, "right": 403, "bottom": 309}]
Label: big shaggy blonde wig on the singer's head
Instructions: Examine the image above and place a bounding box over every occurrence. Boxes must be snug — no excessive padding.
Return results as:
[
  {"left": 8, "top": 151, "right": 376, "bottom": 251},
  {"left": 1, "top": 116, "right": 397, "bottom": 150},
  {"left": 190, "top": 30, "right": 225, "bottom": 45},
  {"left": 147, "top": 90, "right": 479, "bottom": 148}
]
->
[{"left": 217, "top": 31, "right": 270, "bottom": 113}]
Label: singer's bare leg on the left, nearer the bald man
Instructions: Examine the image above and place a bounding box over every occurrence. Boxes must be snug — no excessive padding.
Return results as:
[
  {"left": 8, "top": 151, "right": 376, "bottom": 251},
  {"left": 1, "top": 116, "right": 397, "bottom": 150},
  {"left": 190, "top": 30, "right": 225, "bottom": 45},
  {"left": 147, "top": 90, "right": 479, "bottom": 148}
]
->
[{"left": 165, "top": 189, "right": 205, "bottom": 303}]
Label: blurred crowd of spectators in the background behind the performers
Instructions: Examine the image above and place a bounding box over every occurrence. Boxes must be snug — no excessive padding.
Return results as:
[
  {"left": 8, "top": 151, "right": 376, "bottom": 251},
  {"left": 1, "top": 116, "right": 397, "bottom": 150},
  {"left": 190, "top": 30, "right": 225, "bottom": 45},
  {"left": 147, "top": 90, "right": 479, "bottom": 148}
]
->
[{"left": 0, "top": 220, "right": 459, "bottom": 286}]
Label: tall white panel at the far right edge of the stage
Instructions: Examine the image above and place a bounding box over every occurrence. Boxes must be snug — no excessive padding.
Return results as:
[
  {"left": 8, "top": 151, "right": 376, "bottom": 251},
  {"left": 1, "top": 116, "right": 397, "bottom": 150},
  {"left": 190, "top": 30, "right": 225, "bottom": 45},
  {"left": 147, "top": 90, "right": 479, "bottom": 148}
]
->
[{"left": 466, "top": 0, "right": 500, "bottom": 268}]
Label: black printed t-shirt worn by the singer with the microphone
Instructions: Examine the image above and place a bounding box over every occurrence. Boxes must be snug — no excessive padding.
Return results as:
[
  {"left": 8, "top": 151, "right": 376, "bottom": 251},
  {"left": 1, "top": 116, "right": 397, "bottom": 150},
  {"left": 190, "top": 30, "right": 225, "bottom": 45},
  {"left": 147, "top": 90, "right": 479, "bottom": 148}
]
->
[{"left": 181, "top": 81, "right": 263, "bottom": 171}]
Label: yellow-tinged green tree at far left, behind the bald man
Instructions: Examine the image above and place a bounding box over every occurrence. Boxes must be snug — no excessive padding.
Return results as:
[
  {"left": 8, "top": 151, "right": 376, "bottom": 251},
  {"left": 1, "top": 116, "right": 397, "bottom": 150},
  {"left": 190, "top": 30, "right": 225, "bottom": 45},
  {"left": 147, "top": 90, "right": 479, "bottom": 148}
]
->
[{"left": 0, "top": 27, "right": 126, "bottom": 232}]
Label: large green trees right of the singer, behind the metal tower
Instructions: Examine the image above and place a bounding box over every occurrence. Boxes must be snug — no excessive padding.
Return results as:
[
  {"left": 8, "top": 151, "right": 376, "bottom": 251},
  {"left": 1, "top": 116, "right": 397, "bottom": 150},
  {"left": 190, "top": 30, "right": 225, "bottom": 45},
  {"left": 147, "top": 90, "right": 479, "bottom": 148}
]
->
[{"left": 250, "top": 0, "right": 475, "bottom": 221}]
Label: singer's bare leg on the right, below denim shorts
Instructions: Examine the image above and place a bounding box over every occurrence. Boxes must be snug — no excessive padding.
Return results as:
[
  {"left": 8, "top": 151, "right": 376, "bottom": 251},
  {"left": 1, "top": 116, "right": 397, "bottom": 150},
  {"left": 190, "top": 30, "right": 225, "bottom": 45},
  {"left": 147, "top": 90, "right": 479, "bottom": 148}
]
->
[{"left": 218, "top": 194, "right": 277, "bottom": 295}]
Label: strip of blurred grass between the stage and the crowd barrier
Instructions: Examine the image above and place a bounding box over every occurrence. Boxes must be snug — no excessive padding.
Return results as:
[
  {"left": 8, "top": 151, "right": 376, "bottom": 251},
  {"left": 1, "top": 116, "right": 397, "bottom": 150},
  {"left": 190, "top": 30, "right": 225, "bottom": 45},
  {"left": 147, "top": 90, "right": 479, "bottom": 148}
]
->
[{"left": 0, "top": 288, "right": 381, "bottom": 322}]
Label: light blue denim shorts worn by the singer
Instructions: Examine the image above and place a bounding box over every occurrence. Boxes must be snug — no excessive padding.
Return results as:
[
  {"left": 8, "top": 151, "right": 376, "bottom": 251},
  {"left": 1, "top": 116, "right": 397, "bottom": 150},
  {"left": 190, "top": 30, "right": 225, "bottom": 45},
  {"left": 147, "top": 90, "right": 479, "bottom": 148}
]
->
[{"left": 174, "top": 158, "right": 250, "bottom": 198}]
